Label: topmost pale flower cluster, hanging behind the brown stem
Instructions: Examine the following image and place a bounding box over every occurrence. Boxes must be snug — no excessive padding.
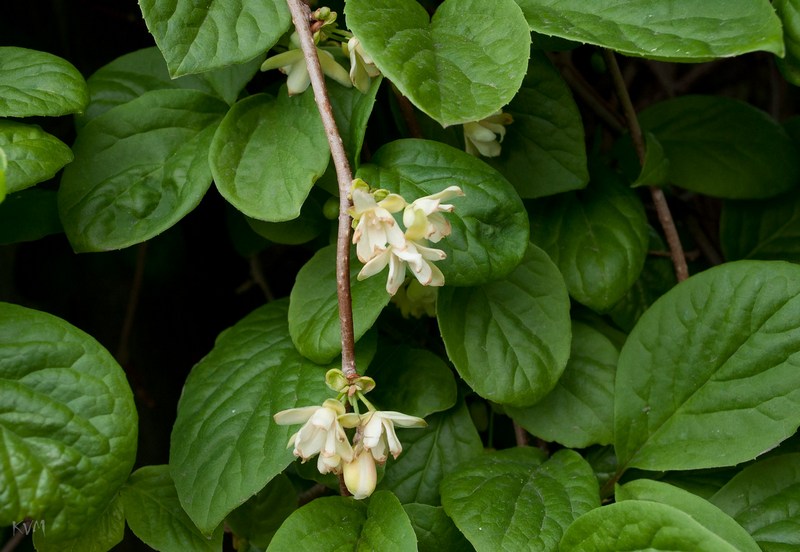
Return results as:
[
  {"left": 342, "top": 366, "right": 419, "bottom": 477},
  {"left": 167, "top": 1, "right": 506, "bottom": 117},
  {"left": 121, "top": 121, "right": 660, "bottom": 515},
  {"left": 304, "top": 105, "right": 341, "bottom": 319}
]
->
[{"left": 261, "top": 8, "right": 380, "bottom": 96}]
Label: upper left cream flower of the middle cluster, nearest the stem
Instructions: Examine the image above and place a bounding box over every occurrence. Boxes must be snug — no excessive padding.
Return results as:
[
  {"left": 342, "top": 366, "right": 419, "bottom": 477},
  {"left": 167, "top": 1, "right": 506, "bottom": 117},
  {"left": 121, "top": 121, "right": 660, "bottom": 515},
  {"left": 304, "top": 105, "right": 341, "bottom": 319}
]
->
[{"left": 348, "top": 179, "right": 406, "bottom": 266}]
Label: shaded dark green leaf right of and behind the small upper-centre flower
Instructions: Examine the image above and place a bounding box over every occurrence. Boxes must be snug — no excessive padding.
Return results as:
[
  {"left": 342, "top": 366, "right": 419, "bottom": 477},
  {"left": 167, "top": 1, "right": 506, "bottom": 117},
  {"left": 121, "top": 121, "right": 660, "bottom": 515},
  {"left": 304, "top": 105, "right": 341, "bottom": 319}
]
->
[{"left": 485, "top": 50, "right": 589, "bottom": 198}]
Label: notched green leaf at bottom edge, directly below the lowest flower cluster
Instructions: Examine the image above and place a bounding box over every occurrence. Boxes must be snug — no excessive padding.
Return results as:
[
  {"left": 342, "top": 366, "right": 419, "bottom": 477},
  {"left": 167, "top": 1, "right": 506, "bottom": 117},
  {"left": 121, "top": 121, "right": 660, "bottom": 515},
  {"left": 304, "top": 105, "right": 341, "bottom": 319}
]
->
[{"left": 268, "top": 491, "right": 417, "bottom": 552}]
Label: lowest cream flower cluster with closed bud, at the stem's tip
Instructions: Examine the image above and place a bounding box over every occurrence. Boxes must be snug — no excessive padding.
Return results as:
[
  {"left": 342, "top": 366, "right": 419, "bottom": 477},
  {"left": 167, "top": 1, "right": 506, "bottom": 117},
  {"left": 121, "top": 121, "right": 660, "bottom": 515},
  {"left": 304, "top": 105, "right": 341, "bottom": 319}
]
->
[{"left": 273, "top": 369, "right": 428, "bottom": 499}]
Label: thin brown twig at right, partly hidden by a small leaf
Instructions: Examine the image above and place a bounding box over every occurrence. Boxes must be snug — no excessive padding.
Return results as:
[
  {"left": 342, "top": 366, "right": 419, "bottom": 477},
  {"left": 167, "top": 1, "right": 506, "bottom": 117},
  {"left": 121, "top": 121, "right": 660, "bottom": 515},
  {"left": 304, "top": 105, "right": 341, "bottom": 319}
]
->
[{"left": 603, "top": 50, "right": 689, "bottom": 282}]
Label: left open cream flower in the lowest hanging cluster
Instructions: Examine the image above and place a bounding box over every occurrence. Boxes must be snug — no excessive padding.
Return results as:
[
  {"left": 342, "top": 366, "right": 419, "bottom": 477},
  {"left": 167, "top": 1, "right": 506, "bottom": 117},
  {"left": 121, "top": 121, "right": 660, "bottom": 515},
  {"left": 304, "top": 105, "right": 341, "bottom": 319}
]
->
[{"left": 273, "top": 399, "right": 353, "bottom": 473}]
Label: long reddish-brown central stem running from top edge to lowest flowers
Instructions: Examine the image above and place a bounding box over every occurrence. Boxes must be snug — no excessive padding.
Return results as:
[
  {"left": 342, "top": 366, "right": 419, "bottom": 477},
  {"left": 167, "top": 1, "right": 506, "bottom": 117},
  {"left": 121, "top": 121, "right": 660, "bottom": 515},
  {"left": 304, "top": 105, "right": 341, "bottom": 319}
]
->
[{"left": 286, "top": 0, "right": 358, "bottom": 378}]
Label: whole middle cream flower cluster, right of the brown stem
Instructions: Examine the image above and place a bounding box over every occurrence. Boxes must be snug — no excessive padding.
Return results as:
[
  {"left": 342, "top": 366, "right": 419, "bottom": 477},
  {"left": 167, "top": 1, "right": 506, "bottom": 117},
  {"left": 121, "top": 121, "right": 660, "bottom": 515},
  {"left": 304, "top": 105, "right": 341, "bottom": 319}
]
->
[{"left": 349, "top": 178, "right": 464, "bottom": 295}]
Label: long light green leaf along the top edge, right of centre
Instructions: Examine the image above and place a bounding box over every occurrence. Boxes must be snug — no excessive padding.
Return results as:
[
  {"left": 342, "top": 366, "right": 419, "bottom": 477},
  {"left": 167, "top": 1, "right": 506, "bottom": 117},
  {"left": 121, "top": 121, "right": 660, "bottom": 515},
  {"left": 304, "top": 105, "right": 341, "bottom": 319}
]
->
[{"left": 517, "top": 0, "right": 783, "bottom": 62}]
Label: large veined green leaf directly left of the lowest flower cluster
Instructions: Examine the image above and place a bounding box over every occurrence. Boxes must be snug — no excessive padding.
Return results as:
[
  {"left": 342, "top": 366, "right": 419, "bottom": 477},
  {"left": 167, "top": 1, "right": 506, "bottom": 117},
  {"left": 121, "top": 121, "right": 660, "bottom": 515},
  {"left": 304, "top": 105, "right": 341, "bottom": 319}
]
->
[{"left": 170, "top": 300, "right": 330, "bottom": 534}]
